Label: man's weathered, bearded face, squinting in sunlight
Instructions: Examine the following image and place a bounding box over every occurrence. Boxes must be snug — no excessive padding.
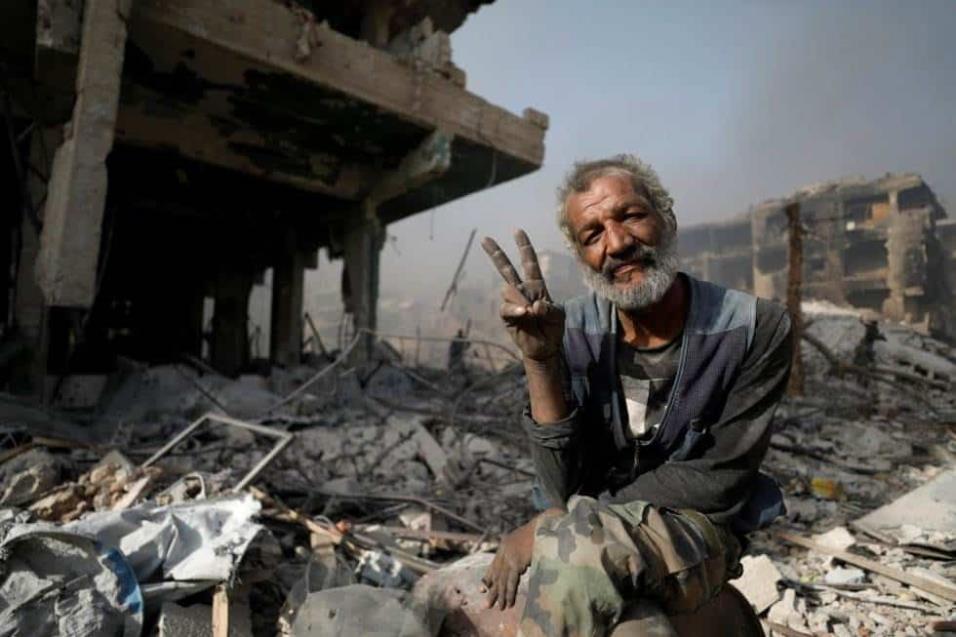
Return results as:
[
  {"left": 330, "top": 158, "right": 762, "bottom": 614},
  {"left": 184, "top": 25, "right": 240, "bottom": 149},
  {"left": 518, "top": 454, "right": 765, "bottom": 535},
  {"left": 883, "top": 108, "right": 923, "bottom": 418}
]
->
[{"left": 566, "top": 175, "right": 677, "bottom": 310}]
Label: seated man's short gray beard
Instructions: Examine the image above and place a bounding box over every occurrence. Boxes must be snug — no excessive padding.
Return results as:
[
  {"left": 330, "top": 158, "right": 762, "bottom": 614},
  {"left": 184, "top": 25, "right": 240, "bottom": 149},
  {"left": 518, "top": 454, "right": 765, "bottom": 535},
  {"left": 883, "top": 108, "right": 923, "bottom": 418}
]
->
[{"left": 575, "top": 241, "right": 680, "bottom": 312}]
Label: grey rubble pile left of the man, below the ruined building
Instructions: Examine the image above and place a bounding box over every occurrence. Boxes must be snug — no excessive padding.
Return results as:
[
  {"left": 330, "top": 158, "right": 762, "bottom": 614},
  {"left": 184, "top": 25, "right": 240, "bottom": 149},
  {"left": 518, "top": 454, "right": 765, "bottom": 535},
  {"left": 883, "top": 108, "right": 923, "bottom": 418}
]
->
[{"left": 0, "top": 348, "right": 534, "bottom": 635}]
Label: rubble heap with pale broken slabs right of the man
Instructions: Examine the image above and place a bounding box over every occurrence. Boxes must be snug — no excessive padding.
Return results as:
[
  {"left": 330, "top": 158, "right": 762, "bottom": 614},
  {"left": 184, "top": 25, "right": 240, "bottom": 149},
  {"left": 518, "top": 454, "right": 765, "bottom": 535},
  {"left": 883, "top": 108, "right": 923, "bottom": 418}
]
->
[{"left": 735, "top": 303, "right": 956, "bottom": 636}]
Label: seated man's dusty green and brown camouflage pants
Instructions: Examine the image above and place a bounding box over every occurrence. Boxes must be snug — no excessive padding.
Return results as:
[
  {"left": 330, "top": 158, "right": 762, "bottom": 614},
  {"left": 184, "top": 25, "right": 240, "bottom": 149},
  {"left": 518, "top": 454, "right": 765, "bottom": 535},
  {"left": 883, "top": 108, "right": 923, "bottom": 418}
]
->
[{"left": 518, "top": 496, "right": 740, "bottom": 637}]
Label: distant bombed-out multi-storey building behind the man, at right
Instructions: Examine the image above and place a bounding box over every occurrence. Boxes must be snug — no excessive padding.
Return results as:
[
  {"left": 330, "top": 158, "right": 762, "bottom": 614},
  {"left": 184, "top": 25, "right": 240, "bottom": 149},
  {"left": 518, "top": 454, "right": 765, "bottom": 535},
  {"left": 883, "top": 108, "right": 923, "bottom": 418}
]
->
[{"left": 679, "top": 174, "right": 956, "bottom": 340}]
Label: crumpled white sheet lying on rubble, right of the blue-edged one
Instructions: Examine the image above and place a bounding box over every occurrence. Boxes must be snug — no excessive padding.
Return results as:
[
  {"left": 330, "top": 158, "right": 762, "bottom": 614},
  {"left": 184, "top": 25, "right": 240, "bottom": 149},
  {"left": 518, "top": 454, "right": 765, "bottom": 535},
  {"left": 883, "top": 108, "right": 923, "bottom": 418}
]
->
[{"left": 63, "top": 494, "right": 263, "bottom": 583}]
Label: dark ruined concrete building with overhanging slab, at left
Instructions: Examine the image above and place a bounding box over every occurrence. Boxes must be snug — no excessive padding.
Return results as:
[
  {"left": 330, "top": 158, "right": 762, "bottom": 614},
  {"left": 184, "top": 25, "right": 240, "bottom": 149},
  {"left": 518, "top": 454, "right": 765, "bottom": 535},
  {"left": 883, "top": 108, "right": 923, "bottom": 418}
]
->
[{"left": 0, "top": 0, "right": 548, "bottom": 394}]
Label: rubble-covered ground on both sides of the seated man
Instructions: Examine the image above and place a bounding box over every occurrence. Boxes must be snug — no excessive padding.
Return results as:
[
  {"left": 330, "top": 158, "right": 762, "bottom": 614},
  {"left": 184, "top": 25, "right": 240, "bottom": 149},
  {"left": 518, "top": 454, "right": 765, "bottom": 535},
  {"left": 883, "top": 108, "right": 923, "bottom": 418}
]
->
[{"left": 0, "top": 306, "right": 956, "bottom": 636}]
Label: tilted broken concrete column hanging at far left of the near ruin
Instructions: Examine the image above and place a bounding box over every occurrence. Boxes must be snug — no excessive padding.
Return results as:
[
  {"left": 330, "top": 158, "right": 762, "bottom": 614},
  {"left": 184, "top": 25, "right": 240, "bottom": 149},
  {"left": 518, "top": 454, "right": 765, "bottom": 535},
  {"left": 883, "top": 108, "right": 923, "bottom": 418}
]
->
[{"left": 37, "top": 0, "right": 132, "bottom": 308}]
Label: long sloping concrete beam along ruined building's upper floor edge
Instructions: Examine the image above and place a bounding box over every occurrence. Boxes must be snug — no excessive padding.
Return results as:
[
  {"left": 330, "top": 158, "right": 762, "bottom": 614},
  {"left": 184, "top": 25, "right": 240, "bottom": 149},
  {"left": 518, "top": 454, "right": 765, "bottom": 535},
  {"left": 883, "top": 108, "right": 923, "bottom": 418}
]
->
[{"left": 131, "top": 0, "right": 544, "bottom": 165}]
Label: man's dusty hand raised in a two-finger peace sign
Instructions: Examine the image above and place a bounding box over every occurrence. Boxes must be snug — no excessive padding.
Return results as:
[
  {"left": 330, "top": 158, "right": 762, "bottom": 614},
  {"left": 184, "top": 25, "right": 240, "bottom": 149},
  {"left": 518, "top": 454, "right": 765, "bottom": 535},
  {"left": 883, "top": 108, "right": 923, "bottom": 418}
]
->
[{"left": 481, "top": 230, "right": 564, "bottom": 361}]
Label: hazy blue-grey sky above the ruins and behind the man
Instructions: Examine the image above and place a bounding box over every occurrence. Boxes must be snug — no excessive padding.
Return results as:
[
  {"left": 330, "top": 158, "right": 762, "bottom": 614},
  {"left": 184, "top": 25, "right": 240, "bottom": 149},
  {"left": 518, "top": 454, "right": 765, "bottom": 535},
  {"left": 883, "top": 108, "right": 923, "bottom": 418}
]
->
[{"left": 330, "top": 0, "right": 956, "bottom": 306}]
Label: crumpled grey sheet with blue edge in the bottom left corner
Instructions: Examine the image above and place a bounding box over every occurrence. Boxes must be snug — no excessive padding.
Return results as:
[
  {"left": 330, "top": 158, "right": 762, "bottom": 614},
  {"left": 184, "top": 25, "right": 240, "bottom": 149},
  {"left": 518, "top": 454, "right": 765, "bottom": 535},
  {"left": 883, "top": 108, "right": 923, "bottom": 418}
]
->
[{"left": 0, "top": 525, "right": 143, "bottom": 637}]
